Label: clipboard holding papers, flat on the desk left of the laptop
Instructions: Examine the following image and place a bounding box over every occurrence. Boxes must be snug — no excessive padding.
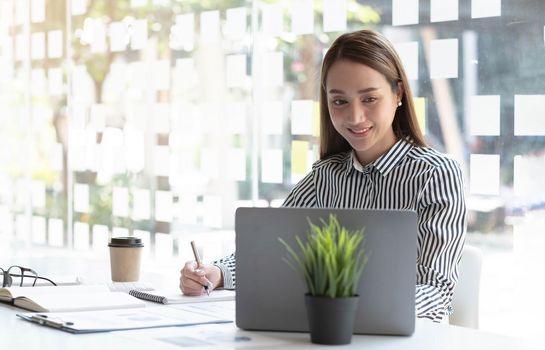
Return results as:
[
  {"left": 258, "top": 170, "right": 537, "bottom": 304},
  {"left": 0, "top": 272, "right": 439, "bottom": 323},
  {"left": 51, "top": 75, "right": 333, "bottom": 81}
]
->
[{"left": 17, "top": 306, "right": 233, "bottom": 334}]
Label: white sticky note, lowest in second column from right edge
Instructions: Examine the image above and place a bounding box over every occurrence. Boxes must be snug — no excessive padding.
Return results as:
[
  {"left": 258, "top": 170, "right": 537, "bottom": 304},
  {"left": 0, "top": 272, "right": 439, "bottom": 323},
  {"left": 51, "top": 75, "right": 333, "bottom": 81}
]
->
[{"left": 469, "top": 154, "right": 500, "bottom": 195}]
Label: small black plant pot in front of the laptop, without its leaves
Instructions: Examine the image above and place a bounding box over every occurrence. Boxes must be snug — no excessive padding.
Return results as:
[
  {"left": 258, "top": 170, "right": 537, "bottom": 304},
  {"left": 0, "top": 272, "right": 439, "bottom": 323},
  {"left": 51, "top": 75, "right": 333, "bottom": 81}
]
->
[{"left": 305, "top": 294, "right": 359, "bottom": 345}]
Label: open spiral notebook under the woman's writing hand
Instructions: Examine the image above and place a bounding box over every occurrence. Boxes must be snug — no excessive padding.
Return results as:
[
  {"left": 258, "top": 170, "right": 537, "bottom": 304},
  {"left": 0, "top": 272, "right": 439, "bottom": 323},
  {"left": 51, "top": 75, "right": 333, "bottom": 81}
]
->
[{"left": 129, "top": 290, "right": 235, "bottom": 304}]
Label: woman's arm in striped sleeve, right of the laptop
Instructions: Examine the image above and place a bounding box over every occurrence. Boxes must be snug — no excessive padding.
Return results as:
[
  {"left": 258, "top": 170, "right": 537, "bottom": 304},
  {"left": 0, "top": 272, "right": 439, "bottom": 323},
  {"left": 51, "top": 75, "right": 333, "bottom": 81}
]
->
[{"left": 416, "top": 159, "right": 466, "bottom": 322}]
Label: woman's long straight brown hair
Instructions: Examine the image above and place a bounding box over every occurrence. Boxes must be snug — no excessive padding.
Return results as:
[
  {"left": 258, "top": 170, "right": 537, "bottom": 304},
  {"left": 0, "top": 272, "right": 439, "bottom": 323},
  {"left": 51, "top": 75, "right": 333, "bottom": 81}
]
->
[{"left": 320, "top": 29, "right": 426, "bottom": 159}]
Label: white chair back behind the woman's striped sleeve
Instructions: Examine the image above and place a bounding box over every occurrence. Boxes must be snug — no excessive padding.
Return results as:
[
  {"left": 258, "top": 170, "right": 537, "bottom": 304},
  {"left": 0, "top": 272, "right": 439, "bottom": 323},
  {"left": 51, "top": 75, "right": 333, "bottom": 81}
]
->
[{"left": 449, "top": 245, "right": 482, "bottom": 329}]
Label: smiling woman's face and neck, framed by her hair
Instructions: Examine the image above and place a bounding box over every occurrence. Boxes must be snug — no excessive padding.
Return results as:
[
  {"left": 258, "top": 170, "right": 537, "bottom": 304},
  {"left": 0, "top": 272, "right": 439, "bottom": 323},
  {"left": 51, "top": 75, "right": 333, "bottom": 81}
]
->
[{"left": 325, "top": 59, "right": 403, "bottom": 165}]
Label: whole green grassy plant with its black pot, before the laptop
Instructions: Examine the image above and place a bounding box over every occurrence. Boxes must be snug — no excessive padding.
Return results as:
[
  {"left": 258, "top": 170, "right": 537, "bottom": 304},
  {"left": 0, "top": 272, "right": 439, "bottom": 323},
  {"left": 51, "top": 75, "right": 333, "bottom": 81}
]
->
[{"left": 279, "top": 214, "right": 367, "bottom": 344}]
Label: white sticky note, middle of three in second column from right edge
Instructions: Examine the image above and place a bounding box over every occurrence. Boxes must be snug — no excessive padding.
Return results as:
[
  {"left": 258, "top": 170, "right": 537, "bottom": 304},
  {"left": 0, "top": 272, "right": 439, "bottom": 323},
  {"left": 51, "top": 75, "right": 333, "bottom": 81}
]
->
[{"left": 469, "top": 95, "right": 500, "bottom": 136}]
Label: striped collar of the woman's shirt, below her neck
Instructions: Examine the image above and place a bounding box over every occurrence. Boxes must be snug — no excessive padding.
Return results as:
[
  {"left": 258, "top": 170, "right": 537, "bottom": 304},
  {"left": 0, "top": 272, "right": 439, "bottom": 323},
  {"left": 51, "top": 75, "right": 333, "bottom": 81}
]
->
[{"left": 346, "top": 139, "right": 414, "bottom": 176}]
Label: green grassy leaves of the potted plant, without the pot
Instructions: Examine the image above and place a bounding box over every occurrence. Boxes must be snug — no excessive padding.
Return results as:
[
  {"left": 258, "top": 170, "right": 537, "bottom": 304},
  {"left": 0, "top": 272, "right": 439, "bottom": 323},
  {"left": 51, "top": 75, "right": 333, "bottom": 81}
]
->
[{"left": 279, "top": 214, "right": 367, "bottom": 298}]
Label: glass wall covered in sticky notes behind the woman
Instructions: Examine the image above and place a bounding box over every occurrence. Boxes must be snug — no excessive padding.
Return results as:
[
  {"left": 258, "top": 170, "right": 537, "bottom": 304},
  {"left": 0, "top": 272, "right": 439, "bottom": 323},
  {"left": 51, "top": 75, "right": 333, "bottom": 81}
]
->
[{"left": 0, "top": 0, "right": 545, "bottom": 340}]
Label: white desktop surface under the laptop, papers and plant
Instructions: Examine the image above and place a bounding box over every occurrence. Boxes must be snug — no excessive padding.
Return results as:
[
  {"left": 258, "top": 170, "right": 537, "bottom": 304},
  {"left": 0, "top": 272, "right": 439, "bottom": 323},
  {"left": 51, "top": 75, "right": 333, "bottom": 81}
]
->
[{"left": 0, "top": 257, "right": 545, "bottom": 350}]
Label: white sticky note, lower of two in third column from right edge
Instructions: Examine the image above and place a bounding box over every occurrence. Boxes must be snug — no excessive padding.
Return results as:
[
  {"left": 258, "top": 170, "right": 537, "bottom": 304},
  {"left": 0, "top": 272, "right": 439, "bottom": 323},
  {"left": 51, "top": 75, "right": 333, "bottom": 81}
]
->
[{"left": 430, "top": 39, "right": 458, "bottom": 79}]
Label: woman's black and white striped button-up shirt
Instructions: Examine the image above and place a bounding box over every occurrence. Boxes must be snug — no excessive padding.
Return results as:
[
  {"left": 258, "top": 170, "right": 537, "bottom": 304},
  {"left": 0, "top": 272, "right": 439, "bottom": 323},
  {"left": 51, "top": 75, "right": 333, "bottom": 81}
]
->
[{"left": 215, "top": 139, "right": 466, "bottom": 321}]
